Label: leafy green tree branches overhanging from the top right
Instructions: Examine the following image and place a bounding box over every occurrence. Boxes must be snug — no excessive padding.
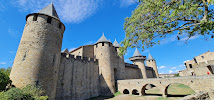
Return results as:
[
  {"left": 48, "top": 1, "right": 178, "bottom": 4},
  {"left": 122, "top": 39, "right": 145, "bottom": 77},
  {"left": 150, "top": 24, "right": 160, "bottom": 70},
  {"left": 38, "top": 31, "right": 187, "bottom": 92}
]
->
[{"left": 120, "top": 0, "right": 214, "bottom": 54}]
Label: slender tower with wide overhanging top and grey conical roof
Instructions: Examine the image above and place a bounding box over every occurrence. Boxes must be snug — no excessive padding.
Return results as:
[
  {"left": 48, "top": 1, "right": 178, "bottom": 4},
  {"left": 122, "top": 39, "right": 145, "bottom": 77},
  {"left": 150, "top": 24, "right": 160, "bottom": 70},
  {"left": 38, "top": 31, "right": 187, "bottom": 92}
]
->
[{"left": 129, "top": 48, "right": 147, "bottom": 79}]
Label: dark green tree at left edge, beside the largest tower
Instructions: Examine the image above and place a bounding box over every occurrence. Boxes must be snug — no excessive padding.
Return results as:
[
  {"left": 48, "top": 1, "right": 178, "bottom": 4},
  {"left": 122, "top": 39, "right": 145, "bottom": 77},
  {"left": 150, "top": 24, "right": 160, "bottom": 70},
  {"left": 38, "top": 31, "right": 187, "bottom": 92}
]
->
[{"left": 0, "top": 67, "right": 12, "bottom": 91}]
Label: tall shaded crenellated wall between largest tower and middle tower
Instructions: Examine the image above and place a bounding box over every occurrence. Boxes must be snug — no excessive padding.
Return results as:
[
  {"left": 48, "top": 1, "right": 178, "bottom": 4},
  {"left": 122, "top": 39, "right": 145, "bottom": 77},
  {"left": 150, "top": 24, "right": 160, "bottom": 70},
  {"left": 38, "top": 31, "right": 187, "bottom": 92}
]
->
[{"left": 56, "top": 53, "right": 100, "bottom": 100}]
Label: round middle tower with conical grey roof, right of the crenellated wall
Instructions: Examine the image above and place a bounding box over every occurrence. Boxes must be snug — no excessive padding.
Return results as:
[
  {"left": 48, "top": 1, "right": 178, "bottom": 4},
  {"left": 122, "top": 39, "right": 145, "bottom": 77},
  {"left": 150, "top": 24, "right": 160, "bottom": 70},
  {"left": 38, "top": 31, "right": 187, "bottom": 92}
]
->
[{"left": 94, "top": 34, "right": 115, "bottom": 96}]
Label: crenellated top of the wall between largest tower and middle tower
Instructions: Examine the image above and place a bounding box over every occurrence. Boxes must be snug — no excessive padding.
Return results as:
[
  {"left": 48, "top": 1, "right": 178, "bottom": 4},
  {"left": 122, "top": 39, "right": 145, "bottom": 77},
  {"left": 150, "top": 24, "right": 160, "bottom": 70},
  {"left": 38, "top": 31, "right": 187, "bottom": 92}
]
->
[{"left": 61, "top": 53, "right": 98, "bottom": 64}]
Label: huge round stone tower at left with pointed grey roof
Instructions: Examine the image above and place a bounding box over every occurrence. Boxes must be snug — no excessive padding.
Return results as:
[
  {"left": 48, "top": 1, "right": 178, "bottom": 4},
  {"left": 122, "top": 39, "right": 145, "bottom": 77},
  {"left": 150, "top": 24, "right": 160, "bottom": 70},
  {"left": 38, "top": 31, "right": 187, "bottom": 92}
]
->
[{"left": 10, "top": 4, "right": 65, "bottom": 99}]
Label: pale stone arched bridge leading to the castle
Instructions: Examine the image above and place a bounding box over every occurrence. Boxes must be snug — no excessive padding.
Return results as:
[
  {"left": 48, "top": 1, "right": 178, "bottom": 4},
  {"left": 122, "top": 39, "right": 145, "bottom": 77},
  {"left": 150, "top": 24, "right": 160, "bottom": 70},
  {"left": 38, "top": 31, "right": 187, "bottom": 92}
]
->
[{"left": 118, "top": 75, "right": 214, "bottom": 97}]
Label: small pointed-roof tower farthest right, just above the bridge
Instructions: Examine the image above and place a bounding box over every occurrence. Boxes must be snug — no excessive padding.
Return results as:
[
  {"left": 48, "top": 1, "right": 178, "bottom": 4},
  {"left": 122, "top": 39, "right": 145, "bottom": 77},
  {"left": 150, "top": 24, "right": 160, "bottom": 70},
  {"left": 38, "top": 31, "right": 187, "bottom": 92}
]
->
[{"left": 146, "top": 53, "right": 159, "bottom": 78}]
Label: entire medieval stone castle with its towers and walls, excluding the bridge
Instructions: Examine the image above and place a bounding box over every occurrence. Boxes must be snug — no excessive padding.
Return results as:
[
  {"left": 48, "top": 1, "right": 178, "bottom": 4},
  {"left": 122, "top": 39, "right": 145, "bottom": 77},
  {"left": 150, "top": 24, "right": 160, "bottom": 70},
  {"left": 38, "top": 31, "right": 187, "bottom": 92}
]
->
[{"left": 10, "top": 4, "right": 158, "bottom": 100}]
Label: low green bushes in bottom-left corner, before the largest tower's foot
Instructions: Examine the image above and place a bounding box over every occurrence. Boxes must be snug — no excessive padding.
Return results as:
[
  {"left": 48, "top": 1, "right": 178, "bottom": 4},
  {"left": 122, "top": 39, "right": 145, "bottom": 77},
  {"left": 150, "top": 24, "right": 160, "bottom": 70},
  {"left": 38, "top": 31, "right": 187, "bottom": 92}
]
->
[{"left": 0, "top": 85, "right": 48, "bottom": 100}]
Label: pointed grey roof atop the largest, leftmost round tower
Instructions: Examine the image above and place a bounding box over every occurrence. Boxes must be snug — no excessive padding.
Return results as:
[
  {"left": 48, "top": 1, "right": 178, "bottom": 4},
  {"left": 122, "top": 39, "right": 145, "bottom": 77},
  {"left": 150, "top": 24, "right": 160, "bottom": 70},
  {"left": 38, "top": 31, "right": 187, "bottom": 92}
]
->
[{"left": 39, "top": 3, "right": 59, "bottom": 19}]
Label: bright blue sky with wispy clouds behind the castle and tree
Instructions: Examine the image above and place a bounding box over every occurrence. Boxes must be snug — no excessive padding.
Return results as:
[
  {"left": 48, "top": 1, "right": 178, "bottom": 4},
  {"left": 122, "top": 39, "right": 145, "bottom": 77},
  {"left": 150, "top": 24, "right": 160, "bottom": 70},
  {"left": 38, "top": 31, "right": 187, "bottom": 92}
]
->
[{"left": 0, "top": 0, "right": 214, "bottom": 73}]
